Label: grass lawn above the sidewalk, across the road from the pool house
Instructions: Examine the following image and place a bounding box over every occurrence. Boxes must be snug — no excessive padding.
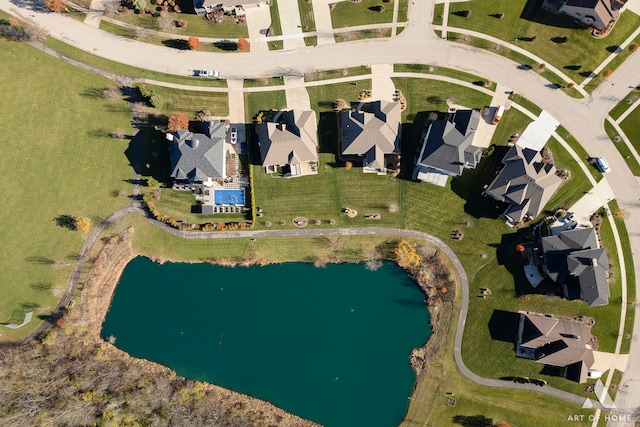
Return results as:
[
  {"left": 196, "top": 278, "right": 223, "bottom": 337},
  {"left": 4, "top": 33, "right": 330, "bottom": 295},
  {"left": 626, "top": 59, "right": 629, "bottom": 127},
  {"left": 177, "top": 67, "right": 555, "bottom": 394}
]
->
[{"left": 109, "top": 12, "right": 249, "bottom": 39}]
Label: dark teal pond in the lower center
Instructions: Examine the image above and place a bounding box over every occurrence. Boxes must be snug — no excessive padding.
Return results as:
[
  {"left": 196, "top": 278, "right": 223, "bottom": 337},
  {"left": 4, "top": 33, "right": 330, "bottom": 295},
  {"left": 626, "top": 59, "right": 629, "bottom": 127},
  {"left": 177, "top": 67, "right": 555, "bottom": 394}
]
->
[{"left": 102, "top": 257, "right": 431, "bottom": 427}]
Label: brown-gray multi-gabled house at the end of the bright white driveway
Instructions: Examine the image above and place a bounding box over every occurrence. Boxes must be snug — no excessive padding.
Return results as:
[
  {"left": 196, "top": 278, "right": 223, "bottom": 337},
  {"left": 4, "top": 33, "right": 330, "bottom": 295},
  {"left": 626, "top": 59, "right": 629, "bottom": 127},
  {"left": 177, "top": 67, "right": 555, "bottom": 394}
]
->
[{"left": 485, "top": 145, "right": 562, "bottom": 223}]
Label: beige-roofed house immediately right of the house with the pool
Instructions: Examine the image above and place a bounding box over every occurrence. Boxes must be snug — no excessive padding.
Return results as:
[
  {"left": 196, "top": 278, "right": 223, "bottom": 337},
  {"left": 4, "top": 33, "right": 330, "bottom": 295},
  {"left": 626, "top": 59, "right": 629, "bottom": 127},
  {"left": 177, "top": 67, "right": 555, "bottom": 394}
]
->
[{"left": 258, "top": 110, "right": 318, "bottom": 178}]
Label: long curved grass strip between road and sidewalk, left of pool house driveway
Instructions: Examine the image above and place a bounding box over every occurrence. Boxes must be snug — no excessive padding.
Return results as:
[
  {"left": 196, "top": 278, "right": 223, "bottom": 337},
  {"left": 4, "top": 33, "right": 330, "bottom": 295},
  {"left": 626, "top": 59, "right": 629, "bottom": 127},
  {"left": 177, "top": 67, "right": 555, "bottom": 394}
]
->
[{"left": 44, "top": 37, "right": 227, "bottom": 87}]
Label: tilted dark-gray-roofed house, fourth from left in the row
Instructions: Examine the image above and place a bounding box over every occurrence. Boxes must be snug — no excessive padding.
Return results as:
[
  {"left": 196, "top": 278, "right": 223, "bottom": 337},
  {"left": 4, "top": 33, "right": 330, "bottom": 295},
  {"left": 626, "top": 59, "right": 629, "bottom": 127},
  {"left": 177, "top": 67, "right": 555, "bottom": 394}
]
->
[{"left": 413, "top": 110, "right": 482, "bottom": 181}]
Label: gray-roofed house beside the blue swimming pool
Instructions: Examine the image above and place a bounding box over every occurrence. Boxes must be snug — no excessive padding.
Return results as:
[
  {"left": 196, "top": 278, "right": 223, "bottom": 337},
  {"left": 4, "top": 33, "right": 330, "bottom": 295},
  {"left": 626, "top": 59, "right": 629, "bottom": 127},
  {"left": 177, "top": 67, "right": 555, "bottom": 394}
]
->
[{"left": 167, "top": 121, "right": 227, "bottom": 187}]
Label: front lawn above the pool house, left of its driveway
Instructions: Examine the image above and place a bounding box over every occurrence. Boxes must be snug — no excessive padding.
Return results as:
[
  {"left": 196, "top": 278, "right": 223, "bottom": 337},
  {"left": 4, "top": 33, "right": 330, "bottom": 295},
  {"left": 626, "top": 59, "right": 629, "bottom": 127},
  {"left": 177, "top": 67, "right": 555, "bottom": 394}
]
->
[{"left": 146, "top": 86, "right": 229, "bottom": 118}]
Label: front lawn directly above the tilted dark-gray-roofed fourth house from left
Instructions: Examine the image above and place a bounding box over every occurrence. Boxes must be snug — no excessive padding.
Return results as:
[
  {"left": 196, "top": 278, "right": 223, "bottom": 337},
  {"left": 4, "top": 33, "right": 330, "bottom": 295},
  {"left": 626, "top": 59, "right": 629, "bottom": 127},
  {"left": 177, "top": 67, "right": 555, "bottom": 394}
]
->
[{"left": 392, "top": 77, "right": 491, "bottom": 122}]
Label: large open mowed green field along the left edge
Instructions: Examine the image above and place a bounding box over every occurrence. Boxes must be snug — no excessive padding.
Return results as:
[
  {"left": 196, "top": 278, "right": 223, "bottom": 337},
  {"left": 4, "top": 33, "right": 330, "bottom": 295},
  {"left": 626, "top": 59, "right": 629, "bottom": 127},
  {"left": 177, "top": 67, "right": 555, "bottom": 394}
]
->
[{"left": 0, "top": 38, "right": 132, "bottom": 339}]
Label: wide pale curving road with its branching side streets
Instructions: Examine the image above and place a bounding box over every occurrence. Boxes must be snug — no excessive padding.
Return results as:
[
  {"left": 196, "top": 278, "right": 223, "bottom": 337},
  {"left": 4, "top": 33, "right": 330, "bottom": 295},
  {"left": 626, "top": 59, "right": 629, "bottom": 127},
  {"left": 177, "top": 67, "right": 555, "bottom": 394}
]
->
[{"left": 0, "top": 0, "right": 640, "bottom": 426}]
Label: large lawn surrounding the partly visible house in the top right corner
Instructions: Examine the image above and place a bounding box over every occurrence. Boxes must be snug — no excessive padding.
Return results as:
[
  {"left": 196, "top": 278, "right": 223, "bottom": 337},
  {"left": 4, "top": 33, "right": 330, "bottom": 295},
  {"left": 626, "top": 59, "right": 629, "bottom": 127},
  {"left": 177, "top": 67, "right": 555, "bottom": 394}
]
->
[{"left": 448, "top": 0, "right": 640, "bottom": 87}]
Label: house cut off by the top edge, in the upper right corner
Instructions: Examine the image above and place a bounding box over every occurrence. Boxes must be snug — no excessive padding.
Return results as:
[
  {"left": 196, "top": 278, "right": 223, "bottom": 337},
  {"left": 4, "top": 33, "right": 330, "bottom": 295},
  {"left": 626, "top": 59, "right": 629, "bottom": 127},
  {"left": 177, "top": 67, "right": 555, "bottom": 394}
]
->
[{"left": 542, "top": 0, "right": 627, "bottom": 30}]
